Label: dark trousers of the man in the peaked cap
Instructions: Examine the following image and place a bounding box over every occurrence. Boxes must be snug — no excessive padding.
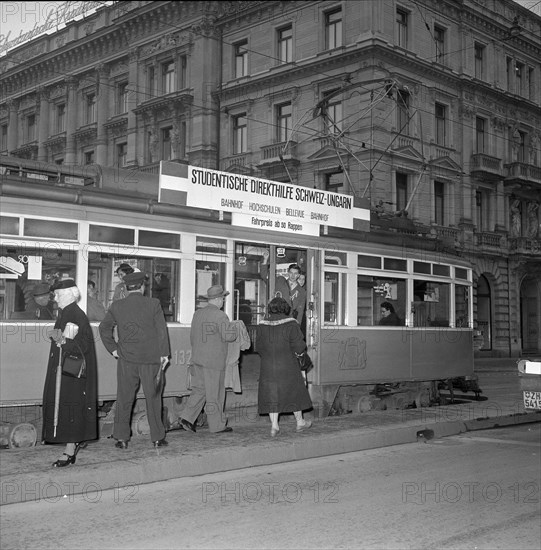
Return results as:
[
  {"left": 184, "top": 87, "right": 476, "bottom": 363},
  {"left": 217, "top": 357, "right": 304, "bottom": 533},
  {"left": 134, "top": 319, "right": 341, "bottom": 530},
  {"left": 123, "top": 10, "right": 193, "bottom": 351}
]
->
[{"left": 113, "top": 359, "right": 165, "bottom": 441}]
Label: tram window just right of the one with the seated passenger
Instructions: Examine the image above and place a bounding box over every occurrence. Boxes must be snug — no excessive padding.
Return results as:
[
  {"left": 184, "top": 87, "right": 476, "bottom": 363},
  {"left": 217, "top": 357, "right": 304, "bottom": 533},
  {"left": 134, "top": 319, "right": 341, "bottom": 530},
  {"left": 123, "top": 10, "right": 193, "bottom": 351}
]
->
[{"left": 413, "top": 280, "right": 450, "bottom": 327}]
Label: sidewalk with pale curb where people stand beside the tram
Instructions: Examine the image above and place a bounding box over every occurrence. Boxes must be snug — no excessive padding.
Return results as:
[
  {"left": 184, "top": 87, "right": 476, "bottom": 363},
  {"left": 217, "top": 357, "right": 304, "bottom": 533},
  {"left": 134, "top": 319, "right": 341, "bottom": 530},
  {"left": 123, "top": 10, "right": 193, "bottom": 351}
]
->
[{"left": 0, "top": 359, "right": 541, "bottom": 504}]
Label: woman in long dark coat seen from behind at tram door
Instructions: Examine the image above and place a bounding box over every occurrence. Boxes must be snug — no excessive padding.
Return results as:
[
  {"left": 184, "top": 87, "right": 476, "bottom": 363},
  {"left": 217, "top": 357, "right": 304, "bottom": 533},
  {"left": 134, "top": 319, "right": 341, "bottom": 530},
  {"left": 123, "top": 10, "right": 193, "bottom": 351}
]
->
[{"left": 256, "top": 298, "right": 312, "bottom": 437}]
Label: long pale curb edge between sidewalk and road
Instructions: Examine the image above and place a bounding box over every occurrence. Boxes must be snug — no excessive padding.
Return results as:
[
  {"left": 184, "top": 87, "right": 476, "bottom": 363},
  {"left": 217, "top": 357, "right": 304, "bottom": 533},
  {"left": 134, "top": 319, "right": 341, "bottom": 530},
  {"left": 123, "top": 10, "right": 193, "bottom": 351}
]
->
[{"left": 0, "top": 411, "right": 541, "bottom": 505}]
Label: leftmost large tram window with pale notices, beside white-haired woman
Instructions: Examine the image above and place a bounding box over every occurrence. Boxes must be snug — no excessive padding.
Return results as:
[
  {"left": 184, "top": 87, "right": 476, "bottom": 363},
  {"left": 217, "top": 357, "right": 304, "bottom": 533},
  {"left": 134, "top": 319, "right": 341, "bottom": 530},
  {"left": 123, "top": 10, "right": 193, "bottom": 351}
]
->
[{"left": 0, "top": 246, "right": 76, "bottom": 322}]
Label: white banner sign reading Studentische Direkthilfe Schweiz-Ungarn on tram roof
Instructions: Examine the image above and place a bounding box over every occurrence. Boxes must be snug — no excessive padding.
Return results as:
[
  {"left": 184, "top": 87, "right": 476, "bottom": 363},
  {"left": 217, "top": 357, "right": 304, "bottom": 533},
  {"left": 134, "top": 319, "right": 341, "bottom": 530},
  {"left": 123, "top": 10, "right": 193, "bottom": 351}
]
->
[{"left": 158, "top": 161, "right": 370, "bottom": 235}]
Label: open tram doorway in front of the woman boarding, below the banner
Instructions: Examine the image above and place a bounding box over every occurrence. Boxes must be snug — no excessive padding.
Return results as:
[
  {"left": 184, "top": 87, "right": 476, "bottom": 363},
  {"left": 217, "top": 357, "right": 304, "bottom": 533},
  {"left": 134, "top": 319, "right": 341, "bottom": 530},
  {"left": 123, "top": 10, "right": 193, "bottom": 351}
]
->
[{"left": 233, "top": 242, "right": 306, "bottom": 327}]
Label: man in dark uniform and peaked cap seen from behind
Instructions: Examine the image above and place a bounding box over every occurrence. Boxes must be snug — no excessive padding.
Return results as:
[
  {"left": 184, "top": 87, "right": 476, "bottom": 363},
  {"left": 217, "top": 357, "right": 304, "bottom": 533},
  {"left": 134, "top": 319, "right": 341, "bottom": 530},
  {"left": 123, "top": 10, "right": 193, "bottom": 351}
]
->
[{"left": 99, "top": 272, "right": 170, "bottom": 449}]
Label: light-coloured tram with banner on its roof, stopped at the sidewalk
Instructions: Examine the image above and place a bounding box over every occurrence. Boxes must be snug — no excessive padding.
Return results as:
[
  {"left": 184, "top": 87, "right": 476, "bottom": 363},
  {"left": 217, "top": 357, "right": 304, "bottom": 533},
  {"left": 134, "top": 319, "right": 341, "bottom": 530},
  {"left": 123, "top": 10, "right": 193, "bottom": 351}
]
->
[{"left": 0, "top": 156, "right": 475, "bottom": 436}]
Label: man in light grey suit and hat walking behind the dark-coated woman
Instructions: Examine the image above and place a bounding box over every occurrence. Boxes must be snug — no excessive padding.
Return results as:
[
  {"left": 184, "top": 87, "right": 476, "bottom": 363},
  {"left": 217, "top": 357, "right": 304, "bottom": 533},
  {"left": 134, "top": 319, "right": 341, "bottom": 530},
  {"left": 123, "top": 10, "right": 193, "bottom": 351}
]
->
[{"left": 180, "top": 285, "right": 237, "bottom": 433}]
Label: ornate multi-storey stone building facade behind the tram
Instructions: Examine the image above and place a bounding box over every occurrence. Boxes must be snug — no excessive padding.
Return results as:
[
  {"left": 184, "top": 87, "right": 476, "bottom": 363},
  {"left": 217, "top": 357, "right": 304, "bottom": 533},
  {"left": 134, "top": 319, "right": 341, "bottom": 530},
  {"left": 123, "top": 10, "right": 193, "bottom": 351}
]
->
[{"left": 0, "top": 0, "right": 541, "bottom": 356}]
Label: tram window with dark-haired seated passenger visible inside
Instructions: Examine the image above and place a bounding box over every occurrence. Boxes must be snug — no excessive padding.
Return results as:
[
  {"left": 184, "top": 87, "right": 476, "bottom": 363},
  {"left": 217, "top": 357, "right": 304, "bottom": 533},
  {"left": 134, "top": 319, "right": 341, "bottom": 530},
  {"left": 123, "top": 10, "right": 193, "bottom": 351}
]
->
[{"left": 357, "top": 275, "right": 406, "bottom": 327}]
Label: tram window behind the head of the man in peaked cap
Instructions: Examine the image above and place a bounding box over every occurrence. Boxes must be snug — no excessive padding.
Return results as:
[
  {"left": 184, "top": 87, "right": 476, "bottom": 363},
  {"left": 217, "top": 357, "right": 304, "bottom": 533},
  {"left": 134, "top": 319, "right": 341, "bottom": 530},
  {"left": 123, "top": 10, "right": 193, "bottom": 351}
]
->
[{"left": 88, "top": 254, "right": 180, "bottom": 321}]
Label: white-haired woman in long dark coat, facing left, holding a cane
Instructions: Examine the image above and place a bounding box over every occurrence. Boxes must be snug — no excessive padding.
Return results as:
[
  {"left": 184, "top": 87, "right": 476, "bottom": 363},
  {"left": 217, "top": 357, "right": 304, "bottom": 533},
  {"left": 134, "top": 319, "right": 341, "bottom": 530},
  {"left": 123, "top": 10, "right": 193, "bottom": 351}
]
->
[{"left": 42, "top": 279, "right": 98, "bottom": 468}]
